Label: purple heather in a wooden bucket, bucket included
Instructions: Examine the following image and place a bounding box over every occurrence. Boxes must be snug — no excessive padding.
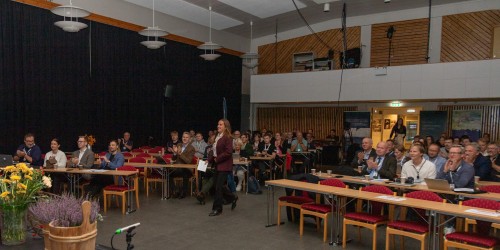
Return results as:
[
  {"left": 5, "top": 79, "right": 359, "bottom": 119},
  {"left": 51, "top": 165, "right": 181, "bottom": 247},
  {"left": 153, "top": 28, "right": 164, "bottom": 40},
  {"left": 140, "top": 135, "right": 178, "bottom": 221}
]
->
[{"left": 29, "top": 193, "right": 102, "bottom": 249}]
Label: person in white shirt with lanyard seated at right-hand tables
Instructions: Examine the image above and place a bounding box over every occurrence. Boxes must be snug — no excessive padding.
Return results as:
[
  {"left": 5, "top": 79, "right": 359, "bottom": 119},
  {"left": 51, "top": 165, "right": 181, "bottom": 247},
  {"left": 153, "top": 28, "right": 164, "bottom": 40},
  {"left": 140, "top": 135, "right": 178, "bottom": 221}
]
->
[{"left": 401, "top": 144, "right": 439, "bottom": 182}]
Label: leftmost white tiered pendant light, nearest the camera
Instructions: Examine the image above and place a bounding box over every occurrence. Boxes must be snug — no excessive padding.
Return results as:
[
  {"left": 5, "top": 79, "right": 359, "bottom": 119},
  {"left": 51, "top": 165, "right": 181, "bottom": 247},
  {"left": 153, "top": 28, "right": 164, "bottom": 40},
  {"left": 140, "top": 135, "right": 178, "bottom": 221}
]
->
[{"left": 50, "top": 0, "right": 90, "bottom": 32}]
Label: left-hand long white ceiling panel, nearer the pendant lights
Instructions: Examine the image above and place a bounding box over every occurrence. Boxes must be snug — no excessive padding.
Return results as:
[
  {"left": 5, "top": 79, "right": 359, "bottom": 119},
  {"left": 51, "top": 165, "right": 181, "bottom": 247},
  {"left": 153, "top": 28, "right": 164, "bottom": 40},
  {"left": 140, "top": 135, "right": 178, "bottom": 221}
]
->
[{"left": 125, "top": 0, "right": 243, "bottom": 30}]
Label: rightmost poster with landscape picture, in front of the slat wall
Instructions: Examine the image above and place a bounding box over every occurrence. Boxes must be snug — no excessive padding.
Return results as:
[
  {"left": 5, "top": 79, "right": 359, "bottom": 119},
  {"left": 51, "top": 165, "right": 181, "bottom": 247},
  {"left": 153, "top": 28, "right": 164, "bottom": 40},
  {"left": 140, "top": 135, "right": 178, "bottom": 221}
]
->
[{"left": 451, "top": 110, "right": 483, "bottom": 141}]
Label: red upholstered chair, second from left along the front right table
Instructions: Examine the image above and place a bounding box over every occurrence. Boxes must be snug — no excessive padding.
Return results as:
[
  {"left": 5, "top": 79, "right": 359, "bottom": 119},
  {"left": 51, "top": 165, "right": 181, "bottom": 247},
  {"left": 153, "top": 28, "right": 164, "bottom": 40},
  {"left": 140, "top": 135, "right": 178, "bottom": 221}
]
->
[{"left": 300, "top": 179, "right": 348, "bottom": 242}]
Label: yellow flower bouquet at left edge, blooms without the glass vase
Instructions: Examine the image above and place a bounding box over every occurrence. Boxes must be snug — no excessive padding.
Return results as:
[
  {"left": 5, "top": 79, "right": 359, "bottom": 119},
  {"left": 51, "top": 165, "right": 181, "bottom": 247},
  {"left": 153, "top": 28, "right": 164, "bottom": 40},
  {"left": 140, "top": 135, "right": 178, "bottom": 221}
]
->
[{"left": 0, "top": 163, "right": 52, "bottom": 205}]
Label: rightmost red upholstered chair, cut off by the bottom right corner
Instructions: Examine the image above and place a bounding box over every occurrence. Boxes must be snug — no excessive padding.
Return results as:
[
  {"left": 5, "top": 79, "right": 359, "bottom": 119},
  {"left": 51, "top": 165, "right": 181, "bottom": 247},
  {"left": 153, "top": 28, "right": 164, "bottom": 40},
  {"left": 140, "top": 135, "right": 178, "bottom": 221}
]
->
[{"left": 444, "top": 199, "right": 500, "bottom": 249}]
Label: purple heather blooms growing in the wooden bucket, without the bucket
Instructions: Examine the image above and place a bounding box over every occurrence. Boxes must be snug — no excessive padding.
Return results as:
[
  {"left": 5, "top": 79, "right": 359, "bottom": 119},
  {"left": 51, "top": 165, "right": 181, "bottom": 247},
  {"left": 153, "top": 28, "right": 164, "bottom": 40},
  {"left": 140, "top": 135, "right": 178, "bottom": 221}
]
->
[{"left": 29, "top": 193, "right": 102, "bottom": 227}]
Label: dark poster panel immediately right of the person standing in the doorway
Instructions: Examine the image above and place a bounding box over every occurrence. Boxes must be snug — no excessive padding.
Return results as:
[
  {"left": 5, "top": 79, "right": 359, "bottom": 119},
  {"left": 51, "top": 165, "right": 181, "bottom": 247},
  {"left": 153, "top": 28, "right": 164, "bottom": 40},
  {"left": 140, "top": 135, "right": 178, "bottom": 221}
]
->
[{"left": 420, "top": 111, "right": 448, "bottom": 141}]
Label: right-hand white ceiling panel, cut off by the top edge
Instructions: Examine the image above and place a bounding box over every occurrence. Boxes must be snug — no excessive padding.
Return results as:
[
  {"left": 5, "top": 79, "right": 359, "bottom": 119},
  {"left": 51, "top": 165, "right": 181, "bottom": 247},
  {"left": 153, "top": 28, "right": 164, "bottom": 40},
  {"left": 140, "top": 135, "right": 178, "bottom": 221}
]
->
[{"left": 218, "top": 0, "right": 306, "bottom": 18}]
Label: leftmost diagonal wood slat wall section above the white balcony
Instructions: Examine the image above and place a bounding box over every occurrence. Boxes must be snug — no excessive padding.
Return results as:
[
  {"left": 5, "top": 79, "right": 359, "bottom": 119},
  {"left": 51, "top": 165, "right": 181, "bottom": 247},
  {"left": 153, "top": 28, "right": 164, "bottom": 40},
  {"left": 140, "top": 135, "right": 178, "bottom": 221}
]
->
[{"left": 258, "top": 26, "right": 361, "bottom": 74}]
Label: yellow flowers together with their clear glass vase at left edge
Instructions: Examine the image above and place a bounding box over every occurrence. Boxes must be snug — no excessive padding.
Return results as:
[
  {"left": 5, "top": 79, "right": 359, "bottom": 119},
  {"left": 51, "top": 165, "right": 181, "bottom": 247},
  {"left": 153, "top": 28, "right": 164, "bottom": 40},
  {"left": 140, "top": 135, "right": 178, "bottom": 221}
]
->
[{"left": 0, "top": 163, "right": 51, "bottom": 245}]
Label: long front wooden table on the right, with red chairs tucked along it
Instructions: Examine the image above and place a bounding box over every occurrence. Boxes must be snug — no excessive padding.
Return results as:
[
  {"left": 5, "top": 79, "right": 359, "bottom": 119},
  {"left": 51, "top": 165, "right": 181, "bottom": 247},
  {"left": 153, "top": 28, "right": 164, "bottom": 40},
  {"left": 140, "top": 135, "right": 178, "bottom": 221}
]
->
[{"left": 266, "top": 179, "right": 500, "bottom": 249}]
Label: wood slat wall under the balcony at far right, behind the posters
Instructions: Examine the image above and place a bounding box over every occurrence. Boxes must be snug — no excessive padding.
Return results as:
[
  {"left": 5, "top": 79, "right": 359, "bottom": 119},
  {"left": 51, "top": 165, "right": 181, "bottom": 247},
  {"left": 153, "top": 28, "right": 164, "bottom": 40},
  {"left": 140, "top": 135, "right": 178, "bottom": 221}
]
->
[{"left": 438, "top": 105, "right": 500, "bottom": 142}]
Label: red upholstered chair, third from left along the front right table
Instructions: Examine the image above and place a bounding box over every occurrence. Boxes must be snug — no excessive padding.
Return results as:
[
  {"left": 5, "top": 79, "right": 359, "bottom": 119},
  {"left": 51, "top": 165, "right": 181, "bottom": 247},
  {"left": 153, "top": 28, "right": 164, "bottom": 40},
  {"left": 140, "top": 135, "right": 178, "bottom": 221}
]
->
[{"left": 342, "top": 185, "right": 396, "bottom": 250}]
